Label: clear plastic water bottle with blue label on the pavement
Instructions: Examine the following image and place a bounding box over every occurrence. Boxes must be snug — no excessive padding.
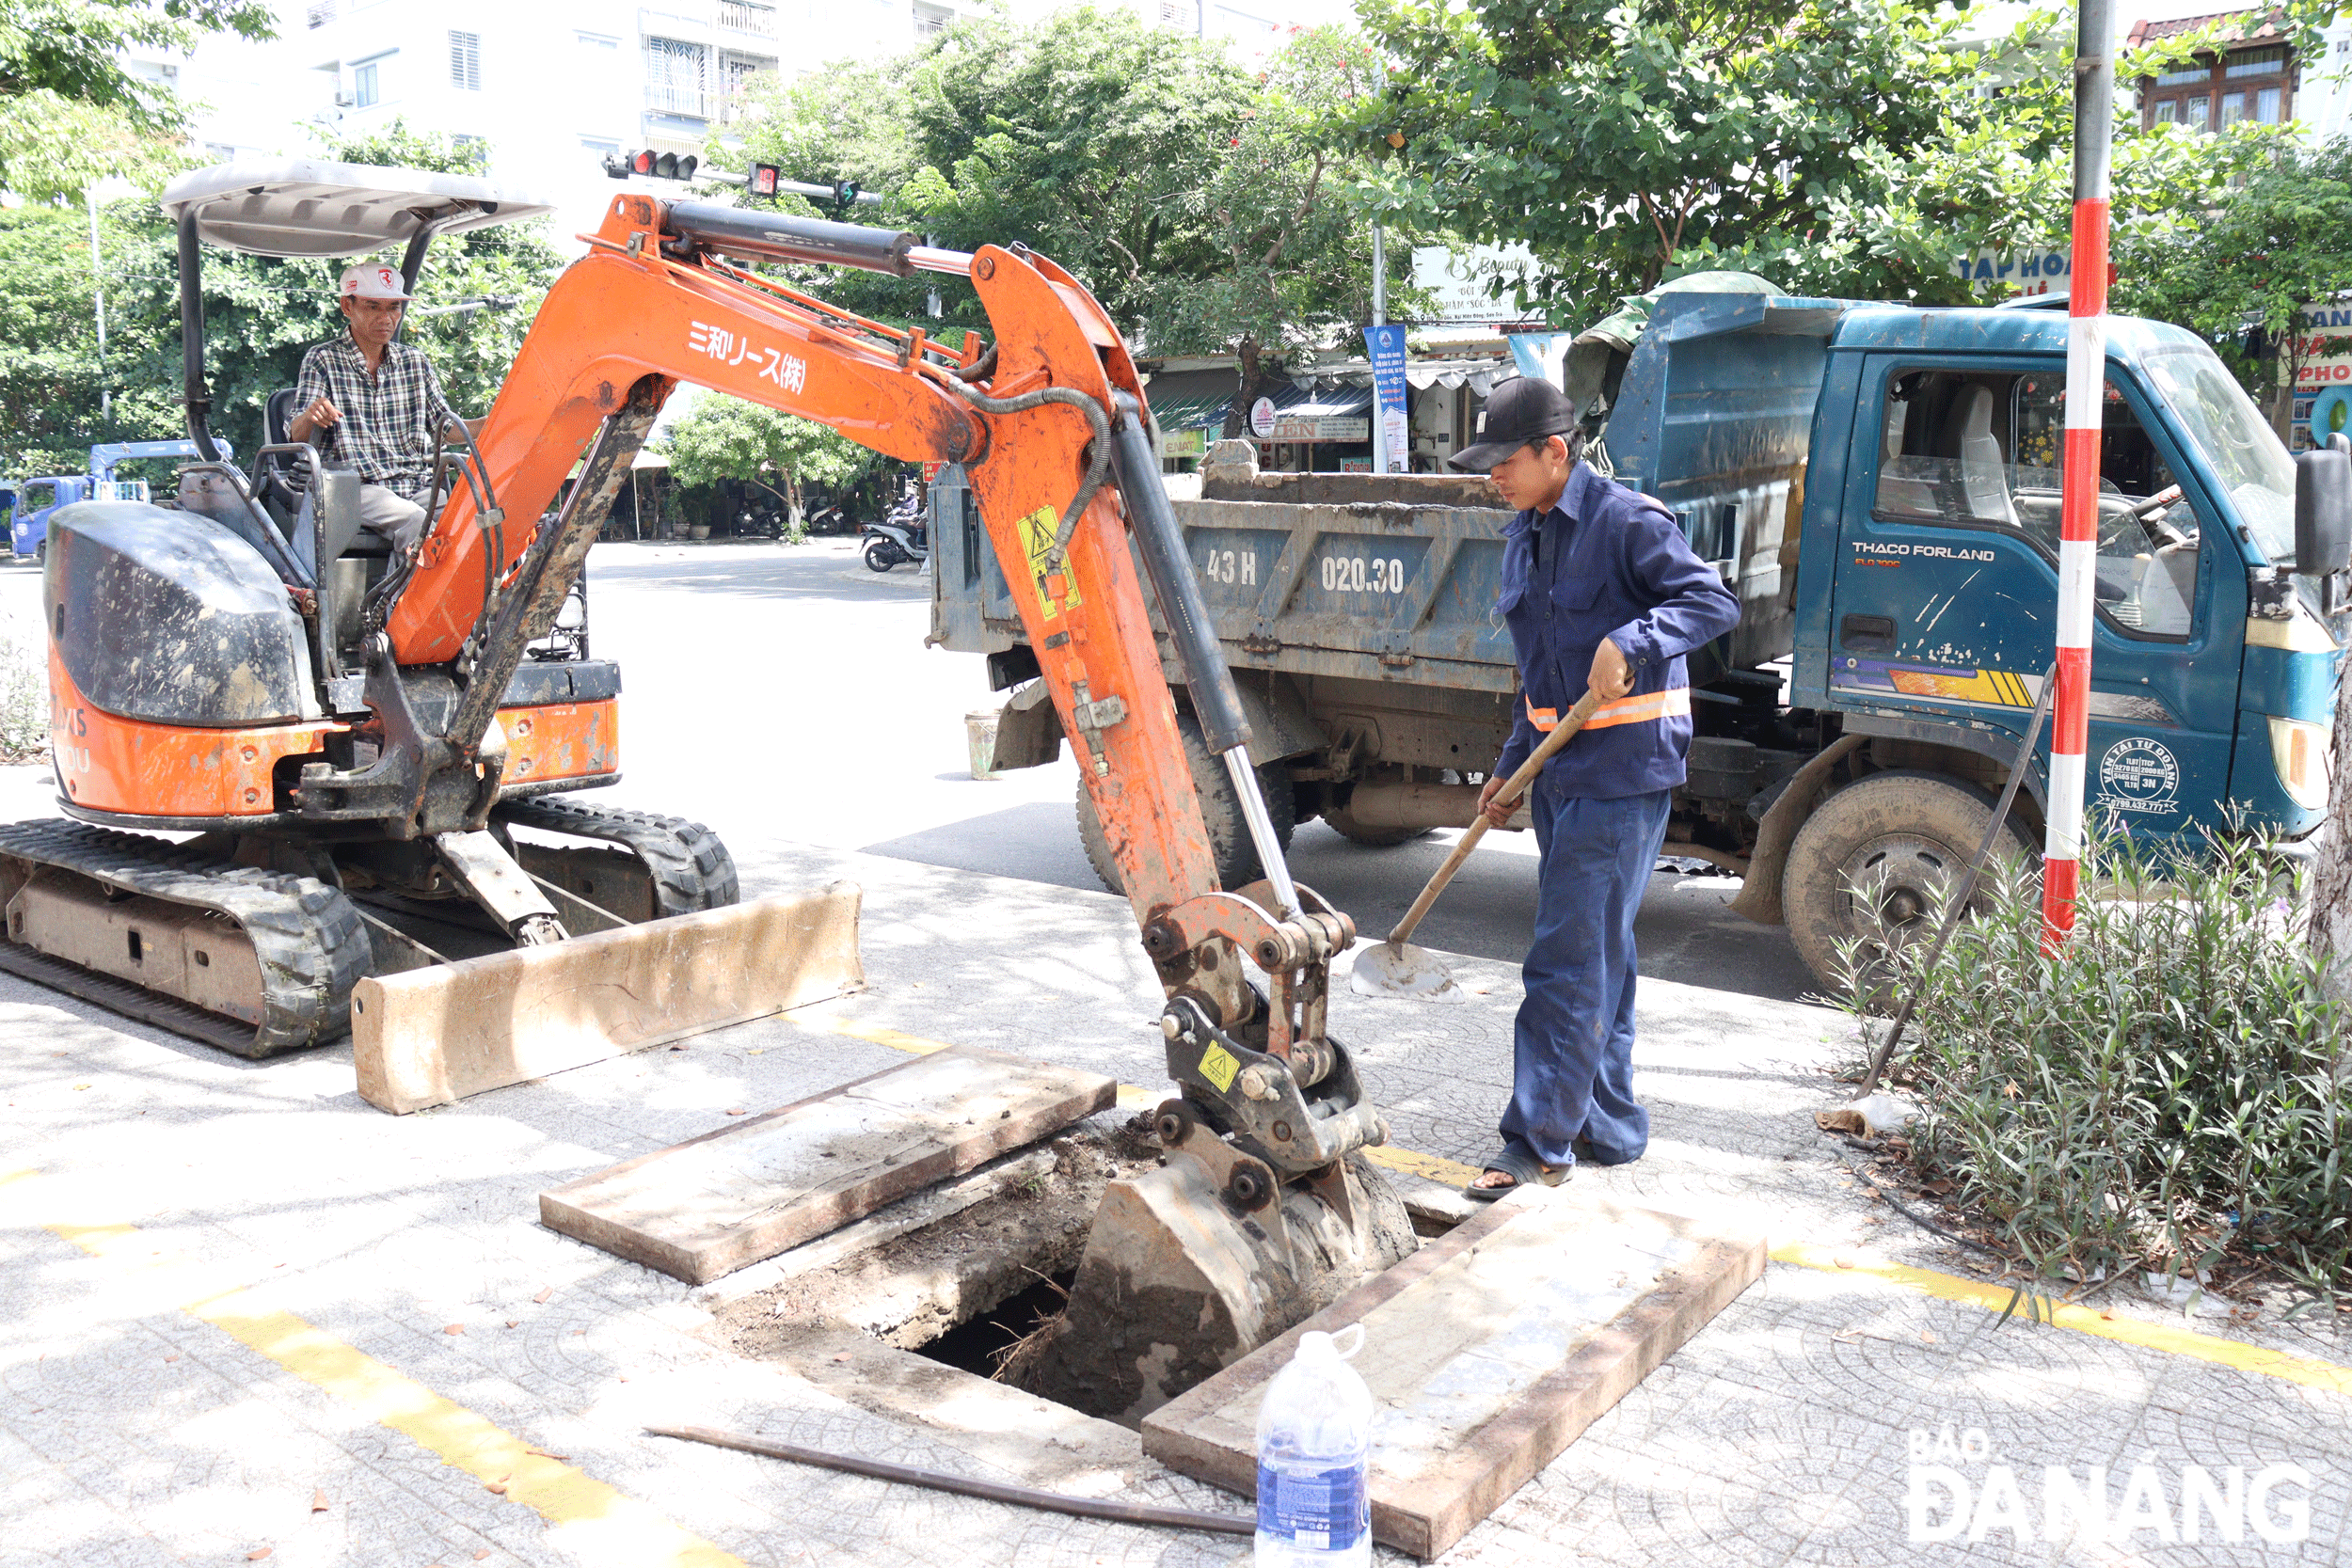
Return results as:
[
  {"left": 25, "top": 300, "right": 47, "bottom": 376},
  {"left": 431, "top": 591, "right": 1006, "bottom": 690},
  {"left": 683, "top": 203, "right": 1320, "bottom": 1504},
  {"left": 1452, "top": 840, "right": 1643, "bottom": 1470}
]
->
[{"left": 1256, "top": 1323, "right": 1372, "bottom": 1568}]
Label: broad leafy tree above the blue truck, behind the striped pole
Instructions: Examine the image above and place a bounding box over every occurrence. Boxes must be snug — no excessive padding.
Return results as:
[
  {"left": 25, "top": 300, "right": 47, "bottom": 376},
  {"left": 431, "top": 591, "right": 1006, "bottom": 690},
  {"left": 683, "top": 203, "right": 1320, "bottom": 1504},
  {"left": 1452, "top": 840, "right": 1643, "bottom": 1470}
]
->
[{"left": 1364, "top": 0, "right": 2286, "bottom": 314}]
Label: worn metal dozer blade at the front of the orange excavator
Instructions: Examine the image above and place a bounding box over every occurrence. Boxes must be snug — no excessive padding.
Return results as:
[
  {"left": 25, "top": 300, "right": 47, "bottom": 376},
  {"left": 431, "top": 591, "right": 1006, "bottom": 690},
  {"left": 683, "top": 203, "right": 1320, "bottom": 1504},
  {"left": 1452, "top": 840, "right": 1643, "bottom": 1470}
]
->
[{"left": 351, "top": 881, "right": 866, "bottom": 1115}]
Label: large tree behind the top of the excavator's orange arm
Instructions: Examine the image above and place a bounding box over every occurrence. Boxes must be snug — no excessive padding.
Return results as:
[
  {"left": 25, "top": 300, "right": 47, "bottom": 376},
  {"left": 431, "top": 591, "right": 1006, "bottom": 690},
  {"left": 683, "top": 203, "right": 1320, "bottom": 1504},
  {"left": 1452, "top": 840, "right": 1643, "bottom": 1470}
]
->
[{"left": 724, "top": 7, "right": 1414, "bottom": 411}]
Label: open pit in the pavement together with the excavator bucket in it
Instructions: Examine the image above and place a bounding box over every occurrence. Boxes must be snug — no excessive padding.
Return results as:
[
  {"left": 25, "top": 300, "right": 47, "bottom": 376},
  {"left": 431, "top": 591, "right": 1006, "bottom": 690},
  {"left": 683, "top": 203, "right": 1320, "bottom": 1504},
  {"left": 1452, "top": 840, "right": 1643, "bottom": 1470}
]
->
[{"left": 715, "top": 1115, "right": 1416, "bottom": 1430}]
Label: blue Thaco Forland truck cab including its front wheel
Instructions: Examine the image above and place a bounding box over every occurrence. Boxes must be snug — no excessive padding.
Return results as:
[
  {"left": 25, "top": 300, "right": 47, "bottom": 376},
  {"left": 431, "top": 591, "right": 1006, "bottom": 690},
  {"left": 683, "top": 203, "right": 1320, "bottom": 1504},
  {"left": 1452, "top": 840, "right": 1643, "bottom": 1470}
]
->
[{"left": 1609, "top": 293, "right": 2347, "bottom": 978}]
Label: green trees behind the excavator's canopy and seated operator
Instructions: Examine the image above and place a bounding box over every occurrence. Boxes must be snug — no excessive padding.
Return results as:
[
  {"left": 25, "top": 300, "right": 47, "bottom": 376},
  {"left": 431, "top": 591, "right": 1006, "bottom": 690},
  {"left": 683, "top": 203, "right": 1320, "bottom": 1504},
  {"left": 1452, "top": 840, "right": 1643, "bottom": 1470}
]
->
[{"left": 0, "top": 122, "right": 563, "bottom": 475}]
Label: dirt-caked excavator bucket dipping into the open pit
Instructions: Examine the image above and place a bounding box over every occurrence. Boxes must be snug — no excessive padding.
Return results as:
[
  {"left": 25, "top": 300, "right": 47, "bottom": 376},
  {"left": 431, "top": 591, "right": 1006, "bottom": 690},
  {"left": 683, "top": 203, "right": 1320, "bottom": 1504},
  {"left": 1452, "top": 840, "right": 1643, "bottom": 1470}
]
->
[{"left": 1005, "top": 1107, "right": 1421, "bottom": 1427}]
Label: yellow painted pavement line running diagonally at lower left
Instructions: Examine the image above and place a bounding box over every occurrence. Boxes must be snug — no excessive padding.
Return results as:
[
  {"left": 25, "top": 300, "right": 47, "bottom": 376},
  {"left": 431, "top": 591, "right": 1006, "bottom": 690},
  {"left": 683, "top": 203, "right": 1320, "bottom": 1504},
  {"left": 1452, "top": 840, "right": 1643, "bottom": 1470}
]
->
[{"left": 0, "top": 1171, "right": 746, "bottom": 1568}]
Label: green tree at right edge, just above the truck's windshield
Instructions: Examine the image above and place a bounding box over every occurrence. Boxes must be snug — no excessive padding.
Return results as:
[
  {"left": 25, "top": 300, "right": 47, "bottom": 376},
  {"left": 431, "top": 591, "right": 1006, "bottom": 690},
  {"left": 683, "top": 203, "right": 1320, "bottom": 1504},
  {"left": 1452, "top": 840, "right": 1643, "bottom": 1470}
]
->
[{"left": 2115, "top": 141, "right": 2352, "bottom": 433}]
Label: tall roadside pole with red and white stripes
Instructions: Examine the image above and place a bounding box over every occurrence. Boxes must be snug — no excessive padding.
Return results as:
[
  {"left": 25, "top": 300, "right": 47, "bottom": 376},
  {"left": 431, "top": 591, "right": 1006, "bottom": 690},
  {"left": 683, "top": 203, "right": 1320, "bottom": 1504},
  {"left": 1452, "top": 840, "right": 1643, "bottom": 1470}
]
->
[{"left": 2042, "top": 0, "right": 2115, "bottom": 955}]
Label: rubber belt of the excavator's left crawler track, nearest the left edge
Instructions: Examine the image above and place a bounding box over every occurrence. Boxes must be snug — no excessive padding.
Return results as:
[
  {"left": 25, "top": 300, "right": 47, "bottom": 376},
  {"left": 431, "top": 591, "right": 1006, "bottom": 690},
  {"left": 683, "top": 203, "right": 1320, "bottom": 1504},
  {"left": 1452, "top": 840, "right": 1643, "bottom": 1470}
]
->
[{"left": 0, "top": 818, "right": 372, "bottom": 1055}]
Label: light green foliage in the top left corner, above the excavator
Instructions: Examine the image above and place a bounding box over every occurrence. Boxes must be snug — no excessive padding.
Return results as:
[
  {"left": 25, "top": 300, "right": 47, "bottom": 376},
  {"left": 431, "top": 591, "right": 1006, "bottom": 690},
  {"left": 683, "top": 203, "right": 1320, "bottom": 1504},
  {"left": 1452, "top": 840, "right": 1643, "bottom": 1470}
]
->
[{"left": 0, "top": 0, "right": 276, "bottom": 202}]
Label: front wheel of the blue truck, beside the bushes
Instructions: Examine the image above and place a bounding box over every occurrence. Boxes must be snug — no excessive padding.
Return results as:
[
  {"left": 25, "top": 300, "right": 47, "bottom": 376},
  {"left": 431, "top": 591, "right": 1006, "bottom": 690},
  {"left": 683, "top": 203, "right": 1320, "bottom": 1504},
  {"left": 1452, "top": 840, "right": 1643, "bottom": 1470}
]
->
[{"left": 1781, "top": 773, "right": 2032, "bottom": 994}]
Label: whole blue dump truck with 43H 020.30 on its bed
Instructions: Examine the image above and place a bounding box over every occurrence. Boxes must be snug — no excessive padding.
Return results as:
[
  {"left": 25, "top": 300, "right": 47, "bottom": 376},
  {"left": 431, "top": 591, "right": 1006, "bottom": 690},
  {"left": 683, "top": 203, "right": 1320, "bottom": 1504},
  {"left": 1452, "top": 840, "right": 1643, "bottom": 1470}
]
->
[{"left": 934, "top": 292, "right": 2352, "bottom": 985}]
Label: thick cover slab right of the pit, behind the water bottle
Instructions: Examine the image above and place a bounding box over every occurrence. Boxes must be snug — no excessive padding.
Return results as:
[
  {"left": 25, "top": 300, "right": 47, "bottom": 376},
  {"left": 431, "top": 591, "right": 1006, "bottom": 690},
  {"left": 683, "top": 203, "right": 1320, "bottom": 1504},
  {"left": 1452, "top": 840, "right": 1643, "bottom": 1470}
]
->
[{"left": 1143, "top": 1187, "right": 1764, "bottom": 1559}]
